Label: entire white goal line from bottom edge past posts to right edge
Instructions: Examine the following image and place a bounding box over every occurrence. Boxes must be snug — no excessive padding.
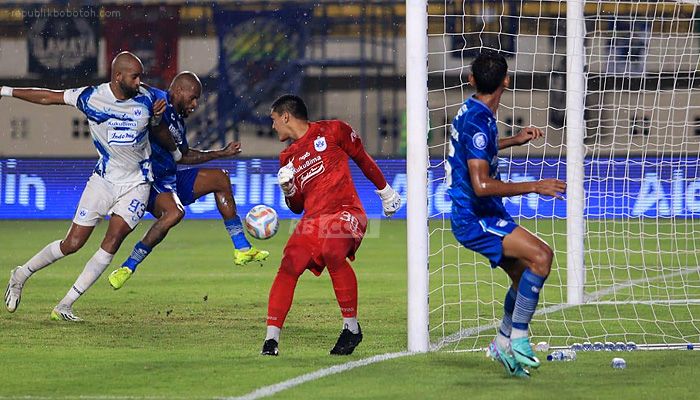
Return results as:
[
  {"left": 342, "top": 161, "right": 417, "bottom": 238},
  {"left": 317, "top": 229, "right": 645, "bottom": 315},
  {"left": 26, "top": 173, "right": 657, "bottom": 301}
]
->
[{"left": 231, "top": 267, "right": 700, "bottom": 400}]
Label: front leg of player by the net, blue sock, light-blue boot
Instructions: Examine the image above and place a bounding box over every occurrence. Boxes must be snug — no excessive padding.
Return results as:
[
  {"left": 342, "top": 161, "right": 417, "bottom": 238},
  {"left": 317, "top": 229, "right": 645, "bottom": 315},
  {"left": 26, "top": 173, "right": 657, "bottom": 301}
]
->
[{"left": 503, "top": 227, "right": 554, "bottom": 368}]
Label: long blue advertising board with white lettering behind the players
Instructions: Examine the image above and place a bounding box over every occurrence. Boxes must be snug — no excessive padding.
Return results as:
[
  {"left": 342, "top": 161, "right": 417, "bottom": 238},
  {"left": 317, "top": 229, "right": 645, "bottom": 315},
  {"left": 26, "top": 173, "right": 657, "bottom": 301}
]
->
[{"left": 0, "top": 158, "right": 700, "bottom": 219}]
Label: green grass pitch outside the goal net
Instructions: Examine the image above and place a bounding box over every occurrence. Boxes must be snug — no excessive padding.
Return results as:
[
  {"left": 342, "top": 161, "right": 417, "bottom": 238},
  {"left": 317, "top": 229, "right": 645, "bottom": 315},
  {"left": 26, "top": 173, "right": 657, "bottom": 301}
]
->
[{"left": 0, "top": 220, "right": 700, "bottom": 400}]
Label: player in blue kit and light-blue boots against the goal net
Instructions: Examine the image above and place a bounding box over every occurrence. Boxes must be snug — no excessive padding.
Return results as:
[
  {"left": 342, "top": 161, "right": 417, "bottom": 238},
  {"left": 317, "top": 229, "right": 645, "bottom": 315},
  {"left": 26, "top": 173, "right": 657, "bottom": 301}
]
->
[{"left": 447, "top": 51, "right": 566, "bottom": 377}]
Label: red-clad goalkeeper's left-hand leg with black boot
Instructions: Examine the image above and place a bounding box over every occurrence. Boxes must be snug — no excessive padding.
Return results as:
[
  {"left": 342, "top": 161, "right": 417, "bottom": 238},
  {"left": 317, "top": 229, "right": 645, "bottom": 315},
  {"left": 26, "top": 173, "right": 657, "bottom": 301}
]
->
[{"left": 260, "top": 242, "right": 311, "bottom": 356}]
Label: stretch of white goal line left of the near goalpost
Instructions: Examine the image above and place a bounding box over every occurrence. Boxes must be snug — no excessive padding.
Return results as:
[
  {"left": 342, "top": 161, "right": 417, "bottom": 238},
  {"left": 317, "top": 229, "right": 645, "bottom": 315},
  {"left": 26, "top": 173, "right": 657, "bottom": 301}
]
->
[{"left": 224, "top": 351, "right": 416, "bottom": 400}]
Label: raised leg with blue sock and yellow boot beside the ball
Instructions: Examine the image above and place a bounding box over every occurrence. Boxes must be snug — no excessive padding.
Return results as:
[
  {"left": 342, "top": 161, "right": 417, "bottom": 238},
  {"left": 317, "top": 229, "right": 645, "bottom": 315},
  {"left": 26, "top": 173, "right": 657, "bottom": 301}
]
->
[{"left": 190, "top": 168, "right": 270, "bottom": 265}]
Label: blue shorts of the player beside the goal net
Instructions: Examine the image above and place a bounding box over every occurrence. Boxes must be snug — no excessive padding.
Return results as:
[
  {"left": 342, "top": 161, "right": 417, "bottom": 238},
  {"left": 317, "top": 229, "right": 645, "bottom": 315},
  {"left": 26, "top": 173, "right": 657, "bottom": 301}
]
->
[{"left": 451, "top": 213, "right": 518, "bottom": 268}]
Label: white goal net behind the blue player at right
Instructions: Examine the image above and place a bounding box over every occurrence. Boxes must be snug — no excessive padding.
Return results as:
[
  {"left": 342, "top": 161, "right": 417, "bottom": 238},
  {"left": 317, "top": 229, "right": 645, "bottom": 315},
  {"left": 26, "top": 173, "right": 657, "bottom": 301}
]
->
[{"left": 428, "top": 0, "right": 700, "bottom": 350}]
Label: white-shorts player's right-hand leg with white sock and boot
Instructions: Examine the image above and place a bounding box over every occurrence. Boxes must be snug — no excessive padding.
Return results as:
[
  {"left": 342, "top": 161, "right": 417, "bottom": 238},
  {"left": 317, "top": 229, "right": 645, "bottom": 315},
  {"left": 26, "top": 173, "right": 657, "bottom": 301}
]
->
[{"left": 51, "top": 214, "right": 135, "bottom": 321}]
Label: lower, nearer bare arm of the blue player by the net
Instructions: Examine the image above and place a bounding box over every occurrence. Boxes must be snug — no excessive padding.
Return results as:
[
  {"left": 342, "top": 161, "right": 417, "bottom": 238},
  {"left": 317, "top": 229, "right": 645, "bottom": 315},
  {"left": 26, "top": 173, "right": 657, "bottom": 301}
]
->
[{"left": 467, "top": 159, "right": 566, "bottom": 200}]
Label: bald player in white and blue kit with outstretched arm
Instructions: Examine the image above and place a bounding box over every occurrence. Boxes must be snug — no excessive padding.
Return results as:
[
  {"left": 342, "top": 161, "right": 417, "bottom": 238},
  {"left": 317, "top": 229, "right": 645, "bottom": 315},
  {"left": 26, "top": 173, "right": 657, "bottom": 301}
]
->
[{"left": 0, "top": 52, "right": 174, "bottom": 321}]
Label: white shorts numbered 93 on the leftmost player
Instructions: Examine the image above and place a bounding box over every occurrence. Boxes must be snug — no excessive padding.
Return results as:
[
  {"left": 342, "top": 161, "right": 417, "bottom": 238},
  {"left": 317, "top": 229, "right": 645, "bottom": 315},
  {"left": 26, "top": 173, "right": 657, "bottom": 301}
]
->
[{"left": 73, "top": 174, "right": 151, "bottom": 229}]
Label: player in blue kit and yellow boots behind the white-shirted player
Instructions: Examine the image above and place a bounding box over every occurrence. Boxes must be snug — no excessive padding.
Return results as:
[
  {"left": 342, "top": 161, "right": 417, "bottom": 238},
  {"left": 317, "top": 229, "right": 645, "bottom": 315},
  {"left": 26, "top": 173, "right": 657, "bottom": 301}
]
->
[{"left": 109, "top": 71, "right": 269, "bottom": 289}]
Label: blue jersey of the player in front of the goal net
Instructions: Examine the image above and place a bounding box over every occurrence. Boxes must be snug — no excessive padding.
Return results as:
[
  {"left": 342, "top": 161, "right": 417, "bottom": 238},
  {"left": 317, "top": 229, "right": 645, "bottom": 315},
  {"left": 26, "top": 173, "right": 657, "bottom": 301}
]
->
[{"left": 446, "top": 97, "right": 508, "bottom": 221}]
